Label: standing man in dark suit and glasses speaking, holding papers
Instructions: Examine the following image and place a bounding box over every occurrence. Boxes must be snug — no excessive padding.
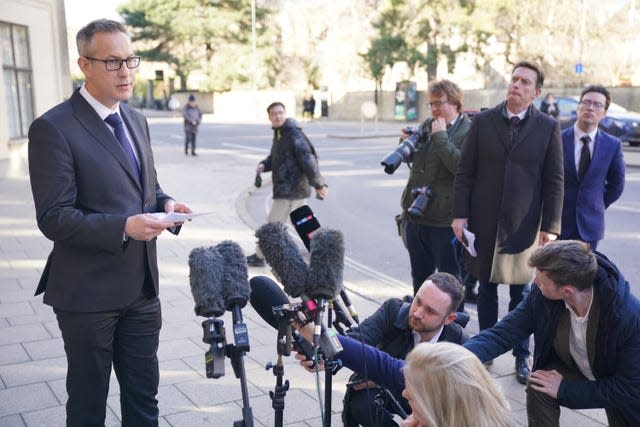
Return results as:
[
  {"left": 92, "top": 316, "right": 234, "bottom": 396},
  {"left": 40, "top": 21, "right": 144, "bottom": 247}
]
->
[{"left": 29, "top": 19, "right": 191, "bottom": 426}]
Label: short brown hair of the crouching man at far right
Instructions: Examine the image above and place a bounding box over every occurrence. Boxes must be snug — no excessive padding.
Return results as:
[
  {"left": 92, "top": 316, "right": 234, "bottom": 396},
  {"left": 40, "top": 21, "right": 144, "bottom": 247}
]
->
[{"left": 529, "top": 240, "right": 598, "bottom": 291}]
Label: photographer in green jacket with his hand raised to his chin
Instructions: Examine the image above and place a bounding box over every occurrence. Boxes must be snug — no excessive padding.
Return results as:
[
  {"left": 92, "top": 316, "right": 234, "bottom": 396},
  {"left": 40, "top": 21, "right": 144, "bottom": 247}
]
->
[{"left": 401, "top": 80, "right": 471, "bottom": 294}]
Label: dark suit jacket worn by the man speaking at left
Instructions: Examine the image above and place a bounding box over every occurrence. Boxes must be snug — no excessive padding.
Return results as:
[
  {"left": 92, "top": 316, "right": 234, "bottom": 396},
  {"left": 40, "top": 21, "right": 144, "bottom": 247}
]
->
[{"left": 29, "top": 91, "right": 175, "bottom": 312}]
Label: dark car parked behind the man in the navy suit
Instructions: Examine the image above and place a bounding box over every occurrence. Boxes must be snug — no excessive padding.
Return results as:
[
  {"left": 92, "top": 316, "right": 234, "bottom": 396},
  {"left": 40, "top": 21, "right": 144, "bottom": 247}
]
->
[{"left": 534, "top": 96, "right": 640, "bottom": 147}]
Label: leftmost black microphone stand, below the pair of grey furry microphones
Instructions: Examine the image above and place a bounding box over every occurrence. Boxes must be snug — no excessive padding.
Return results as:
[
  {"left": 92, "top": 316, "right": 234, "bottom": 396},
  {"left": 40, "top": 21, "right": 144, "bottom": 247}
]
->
[{"left": 227, "top": 304, "right": 253, "bottom": 427}]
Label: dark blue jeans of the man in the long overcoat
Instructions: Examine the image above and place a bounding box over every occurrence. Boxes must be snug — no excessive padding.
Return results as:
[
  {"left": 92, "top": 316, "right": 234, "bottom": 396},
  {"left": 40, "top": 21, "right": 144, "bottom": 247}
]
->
[{"left": 478, "top": 280, "right": 531, "bottom": 357}]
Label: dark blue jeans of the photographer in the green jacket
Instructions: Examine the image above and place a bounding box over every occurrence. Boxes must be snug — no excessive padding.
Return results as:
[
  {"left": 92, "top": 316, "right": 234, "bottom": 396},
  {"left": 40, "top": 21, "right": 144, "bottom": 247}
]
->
[{"left": 404, "top": 221, "right": 460, "bottom": 295}]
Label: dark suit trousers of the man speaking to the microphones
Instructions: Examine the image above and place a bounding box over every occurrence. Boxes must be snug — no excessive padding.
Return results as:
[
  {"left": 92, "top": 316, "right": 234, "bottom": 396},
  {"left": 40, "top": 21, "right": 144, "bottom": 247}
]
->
[{"left": 54, "top": 296, "right": 162, "bottom": 427}]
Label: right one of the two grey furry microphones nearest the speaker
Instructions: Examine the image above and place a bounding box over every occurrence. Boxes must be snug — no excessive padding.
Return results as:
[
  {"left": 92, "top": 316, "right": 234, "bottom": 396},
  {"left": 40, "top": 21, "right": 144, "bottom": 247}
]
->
[{"left": 214, "top": 240, "right": 251, "bottom": 352}]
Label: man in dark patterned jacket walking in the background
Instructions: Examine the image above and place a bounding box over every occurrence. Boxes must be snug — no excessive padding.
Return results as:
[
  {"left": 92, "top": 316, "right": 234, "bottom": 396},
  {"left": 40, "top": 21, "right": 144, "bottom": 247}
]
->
[{"left": 247, "top": 102, "right": 329, "bottom": 267}]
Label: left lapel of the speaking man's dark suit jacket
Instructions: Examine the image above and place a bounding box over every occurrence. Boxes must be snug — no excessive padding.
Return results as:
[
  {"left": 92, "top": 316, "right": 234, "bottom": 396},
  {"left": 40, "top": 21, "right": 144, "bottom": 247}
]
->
[{"left": 71, "top": 91, "right": 141, "bottom": 192}]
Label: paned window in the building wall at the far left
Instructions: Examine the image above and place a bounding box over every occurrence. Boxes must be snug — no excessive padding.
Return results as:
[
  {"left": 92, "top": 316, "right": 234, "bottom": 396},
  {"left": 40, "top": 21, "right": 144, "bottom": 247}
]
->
[{"left": 0, "top": 22, "right": 34, "bottom": 139}]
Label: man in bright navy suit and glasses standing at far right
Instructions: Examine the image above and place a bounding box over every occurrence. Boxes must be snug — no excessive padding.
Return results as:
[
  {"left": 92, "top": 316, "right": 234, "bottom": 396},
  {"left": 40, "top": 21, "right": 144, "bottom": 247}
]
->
[{"left": 560, "top": 85, "right": 624, "bottom": 249}]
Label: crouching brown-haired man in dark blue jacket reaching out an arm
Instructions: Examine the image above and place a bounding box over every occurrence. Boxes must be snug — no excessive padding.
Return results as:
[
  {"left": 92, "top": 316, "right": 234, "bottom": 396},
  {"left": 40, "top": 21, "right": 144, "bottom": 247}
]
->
[{"left": 465, "top": 240, "right": 640, "bottom": 427}]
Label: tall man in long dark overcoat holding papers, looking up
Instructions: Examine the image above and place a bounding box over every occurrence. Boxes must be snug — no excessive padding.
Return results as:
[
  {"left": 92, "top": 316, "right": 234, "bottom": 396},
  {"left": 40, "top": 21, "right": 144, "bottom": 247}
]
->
[{"left": 452, "top": 62, "right": 564, "bottom": 384}]
